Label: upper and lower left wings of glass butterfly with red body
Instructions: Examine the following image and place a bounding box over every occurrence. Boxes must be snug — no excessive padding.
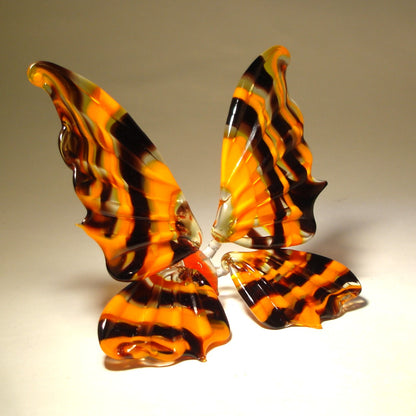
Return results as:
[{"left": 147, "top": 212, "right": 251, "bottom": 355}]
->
[{"left": 28, "top": 62, "right": 230, "bottom": 364}]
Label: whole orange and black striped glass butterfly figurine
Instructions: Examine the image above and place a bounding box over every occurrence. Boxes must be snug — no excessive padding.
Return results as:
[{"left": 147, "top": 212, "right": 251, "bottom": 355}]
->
[{"left": 28, "top": 46, "right": 361, "bottom": 365}]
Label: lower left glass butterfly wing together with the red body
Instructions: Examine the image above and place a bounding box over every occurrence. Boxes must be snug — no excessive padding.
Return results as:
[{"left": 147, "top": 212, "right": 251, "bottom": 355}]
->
[{"left": 98, "top": 252, "right": 231, "bottom": 365}]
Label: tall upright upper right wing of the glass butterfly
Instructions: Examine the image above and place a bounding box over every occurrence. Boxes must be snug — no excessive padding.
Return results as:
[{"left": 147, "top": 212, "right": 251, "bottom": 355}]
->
[{"left": 212, "top": 46, "right": 326, "bottom": 249}]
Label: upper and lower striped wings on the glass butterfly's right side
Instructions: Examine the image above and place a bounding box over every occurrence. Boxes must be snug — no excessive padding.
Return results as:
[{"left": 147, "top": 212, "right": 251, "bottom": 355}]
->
[{"left": 212, "top": 46, "right": 360, "bottom": 328}]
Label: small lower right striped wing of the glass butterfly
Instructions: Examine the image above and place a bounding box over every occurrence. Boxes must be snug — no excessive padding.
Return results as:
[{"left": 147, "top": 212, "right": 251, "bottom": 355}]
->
[{"left": 222, "top": 250, "right": 361, "bottom": 329}]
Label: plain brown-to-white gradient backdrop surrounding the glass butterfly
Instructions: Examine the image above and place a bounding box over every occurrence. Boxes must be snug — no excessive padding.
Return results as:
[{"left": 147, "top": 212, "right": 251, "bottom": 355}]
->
[{"left": 0, "top": 0, "right": 416, "bottom": 416}]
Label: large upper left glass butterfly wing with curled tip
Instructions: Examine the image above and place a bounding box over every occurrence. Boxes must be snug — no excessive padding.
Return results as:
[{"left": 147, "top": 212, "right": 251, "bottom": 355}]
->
[{"left": 28, "top": 62, "right": 201, "bottom": 281}]
